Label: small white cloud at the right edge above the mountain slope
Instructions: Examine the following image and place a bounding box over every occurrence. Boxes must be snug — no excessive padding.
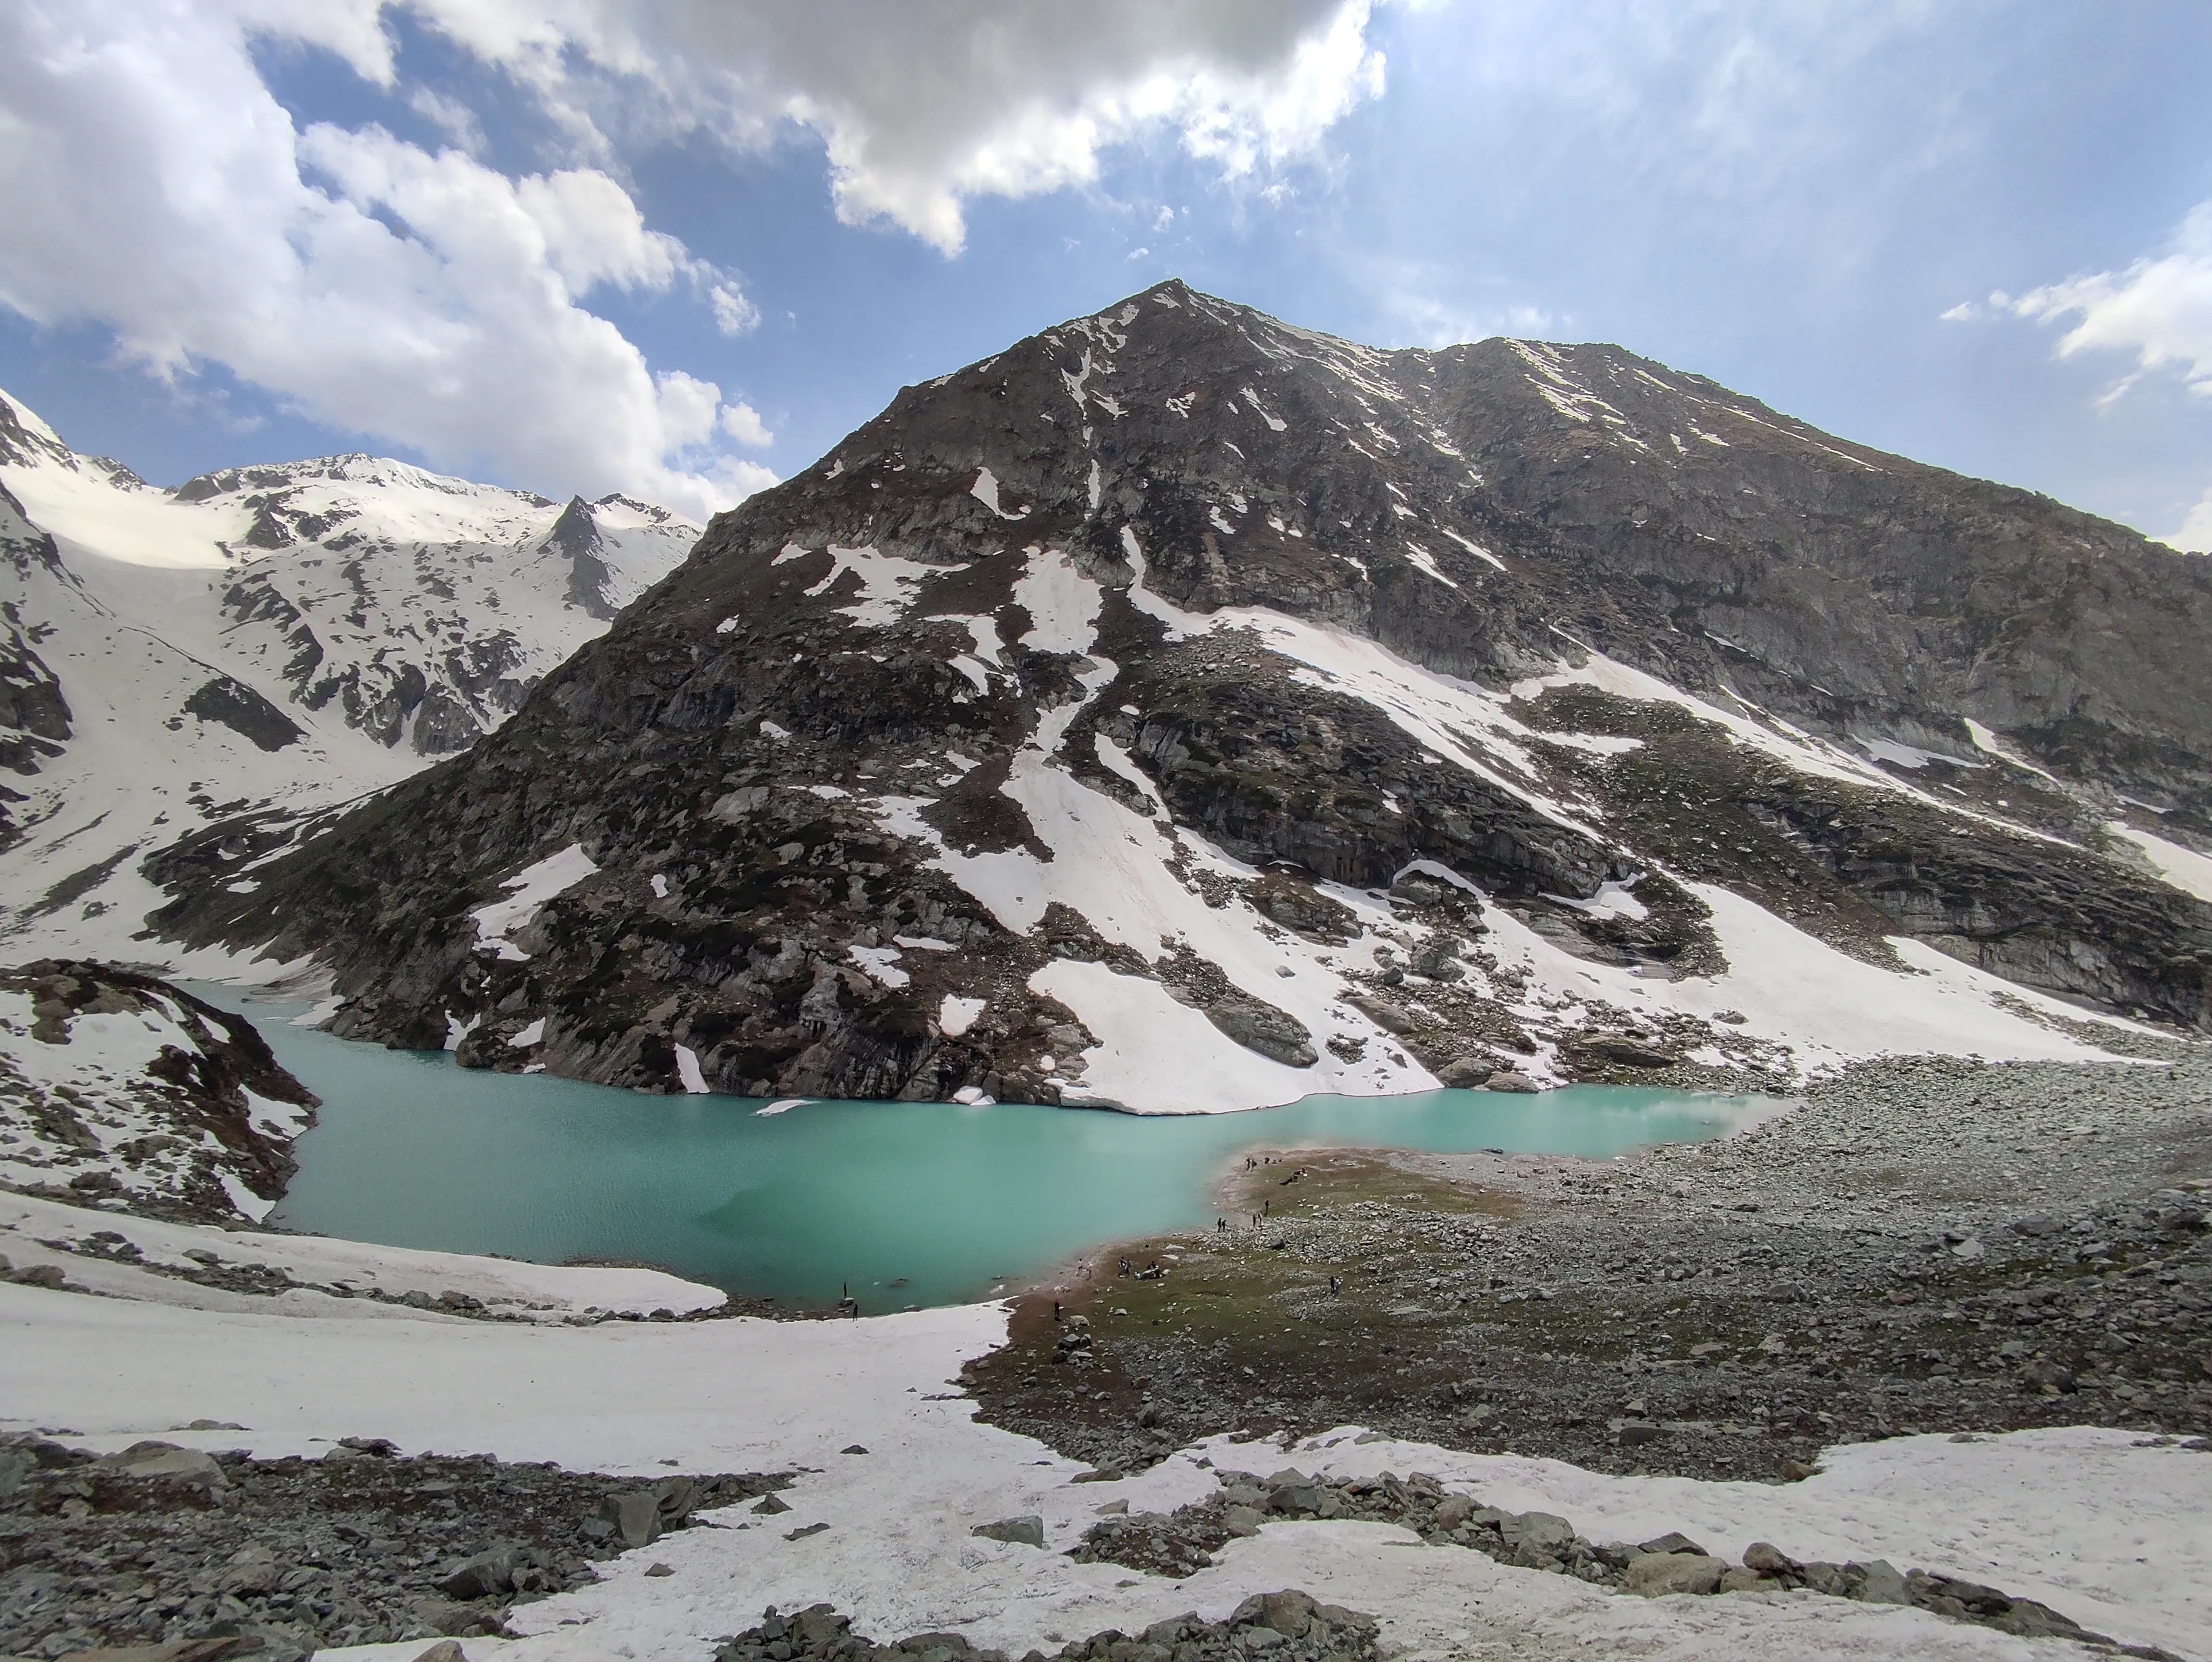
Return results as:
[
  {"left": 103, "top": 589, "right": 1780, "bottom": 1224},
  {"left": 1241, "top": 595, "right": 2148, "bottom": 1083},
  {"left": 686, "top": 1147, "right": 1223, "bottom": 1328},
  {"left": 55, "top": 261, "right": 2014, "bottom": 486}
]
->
[{"left": 1993, "top": 202, "right": 2212, "bottom": 403}]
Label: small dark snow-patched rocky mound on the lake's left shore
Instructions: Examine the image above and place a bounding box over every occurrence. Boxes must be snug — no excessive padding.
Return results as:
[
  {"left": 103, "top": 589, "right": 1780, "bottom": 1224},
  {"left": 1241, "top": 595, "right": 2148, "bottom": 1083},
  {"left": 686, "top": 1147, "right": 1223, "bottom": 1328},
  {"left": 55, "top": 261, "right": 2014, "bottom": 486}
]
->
[{"left": 0, "top": 961, "right": 318, "bottom": 1224}]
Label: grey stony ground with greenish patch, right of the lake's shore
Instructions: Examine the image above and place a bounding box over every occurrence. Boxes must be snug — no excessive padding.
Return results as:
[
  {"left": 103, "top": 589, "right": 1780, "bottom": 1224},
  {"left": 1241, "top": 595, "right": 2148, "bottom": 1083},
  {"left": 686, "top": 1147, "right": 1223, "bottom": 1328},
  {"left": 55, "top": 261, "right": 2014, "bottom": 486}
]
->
[{"left": 966, "top": 1054, "right": 2212, "bottom": 1479}]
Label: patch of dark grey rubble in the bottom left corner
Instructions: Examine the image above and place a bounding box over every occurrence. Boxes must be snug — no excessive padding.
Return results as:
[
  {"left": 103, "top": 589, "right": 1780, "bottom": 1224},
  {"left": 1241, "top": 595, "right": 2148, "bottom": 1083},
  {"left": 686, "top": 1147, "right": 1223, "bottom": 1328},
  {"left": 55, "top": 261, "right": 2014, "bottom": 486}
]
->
[{"left": 0, "top": 1439, "right": 790, "bottom": 1662}]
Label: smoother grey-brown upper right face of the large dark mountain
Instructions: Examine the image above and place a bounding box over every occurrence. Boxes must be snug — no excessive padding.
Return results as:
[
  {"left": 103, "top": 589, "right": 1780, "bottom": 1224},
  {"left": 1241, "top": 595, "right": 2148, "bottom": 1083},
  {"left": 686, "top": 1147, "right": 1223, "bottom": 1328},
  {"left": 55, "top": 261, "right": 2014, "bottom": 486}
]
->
[{"left": 1436, "top": 341, "right": 2212, "bottom": 817}]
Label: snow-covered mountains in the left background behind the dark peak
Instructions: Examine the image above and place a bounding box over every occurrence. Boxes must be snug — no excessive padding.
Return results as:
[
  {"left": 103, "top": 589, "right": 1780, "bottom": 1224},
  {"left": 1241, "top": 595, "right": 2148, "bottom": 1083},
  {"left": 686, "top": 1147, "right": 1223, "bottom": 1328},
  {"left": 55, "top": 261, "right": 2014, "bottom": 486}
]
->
[{"left": 0, "top": 394, "right": 699, "bottom": 958}]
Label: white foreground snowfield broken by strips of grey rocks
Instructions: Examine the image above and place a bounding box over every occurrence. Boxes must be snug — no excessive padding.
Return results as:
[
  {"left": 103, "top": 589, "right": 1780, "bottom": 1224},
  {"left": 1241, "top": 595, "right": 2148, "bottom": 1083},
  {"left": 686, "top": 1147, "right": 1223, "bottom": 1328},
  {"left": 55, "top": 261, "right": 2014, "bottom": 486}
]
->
[{"left": 0, "top": 1248, "right": 2212, "bottom": 1662}]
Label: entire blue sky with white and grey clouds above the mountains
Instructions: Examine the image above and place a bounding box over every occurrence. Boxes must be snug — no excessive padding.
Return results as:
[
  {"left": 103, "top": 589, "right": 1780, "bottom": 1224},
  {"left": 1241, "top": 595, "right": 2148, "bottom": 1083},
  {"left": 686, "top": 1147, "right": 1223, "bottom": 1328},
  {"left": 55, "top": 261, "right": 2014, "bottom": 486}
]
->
[{"left": 0, "top": 0, "right": 2212, "bottom": 551}]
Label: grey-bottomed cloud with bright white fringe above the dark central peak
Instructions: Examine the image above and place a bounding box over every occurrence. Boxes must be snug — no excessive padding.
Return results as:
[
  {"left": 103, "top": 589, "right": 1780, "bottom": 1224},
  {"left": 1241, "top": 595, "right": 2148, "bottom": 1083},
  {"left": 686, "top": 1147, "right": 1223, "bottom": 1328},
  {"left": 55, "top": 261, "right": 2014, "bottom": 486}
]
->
[{"left": 411, "top": 0, "right": 1382, "bottom": 252}]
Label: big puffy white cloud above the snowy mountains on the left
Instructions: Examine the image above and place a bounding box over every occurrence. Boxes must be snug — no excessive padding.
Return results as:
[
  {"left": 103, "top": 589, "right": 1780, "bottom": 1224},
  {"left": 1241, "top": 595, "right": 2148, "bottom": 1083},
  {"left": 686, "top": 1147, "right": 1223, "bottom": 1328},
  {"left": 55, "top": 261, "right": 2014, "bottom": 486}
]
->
[{"left": 0, "top": 0, "right": 774, "bottom": 515}]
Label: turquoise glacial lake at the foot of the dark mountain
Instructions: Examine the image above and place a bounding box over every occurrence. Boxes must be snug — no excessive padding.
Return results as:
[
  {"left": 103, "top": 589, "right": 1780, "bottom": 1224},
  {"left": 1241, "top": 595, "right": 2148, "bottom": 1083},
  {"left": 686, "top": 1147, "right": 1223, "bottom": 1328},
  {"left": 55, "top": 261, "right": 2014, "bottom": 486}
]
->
[{"left": 192, "top": 985, "right": 1772, "bottom": 1313}]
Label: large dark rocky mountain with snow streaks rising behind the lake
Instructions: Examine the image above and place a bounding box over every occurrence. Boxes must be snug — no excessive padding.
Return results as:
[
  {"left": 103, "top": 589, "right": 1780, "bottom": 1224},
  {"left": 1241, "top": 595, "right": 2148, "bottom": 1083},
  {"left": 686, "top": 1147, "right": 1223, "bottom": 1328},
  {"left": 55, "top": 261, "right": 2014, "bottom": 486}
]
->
[{"left": 156, "top": 283, "right": 2212, "bottom": 1111}]
